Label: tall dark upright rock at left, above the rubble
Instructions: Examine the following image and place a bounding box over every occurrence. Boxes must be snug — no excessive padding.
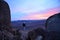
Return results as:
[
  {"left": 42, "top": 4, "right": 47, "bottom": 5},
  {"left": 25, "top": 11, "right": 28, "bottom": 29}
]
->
[{"left": 0, "top": 0, "right": 11, "bottom": 26}]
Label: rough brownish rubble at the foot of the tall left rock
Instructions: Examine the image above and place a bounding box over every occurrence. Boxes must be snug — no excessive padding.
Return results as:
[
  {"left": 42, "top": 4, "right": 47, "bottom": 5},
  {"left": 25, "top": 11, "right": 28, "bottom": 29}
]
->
[{"left": 0, "top": 29, "right": 22, "bottom": 40}]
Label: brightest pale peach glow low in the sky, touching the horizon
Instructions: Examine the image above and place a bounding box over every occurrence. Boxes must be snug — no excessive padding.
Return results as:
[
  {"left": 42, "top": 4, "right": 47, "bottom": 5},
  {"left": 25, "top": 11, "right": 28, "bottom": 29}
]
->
[{"left": 22, "top": 14, "right": 46, "bottom": 20}]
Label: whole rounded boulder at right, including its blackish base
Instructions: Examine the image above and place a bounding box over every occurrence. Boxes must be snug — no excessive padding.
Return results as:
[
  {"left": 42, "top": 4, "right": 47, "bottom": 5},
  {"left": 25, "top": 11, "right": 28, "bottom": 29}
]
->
[{"left": 45, "top": 13, "right": 60, "bottom": 40}]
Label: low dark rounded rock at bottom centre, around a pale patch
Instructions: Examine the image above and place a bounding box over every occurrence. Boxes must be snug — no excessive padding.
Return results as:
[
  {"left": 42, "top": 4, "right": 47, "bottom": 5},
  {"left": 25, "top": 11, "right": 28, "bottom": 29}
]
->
[{"left": 27, "top": 28, "right": 46, "bottom": 40}]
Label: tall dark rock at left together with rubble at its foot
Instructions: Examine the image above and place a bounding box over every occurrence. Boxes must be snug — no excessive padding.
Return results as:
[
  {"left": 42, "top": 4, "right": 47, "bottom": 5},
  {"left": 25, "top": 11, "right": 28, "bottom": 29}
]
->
[{"left": 0, "top": 0, "right": 21, "bottom": 40}]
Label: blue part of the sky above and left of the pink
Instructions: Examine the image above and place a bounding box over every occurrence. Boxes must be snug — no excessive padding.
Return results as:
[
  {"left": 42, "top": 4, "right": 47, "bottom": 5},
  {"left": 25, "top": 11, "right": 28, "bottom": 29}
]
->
[{"left": 6, "top": 0, "right": 60, "bottom": 20}]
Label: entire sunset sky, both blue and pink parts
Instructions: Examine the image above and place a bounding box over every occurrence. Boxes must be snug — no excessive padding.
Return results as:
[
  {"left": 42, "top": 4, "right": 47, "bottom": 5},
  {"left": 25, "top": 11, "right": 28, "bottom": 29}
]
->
[{"left": 5, "top": 0, "right": 60, "bottom": 21}]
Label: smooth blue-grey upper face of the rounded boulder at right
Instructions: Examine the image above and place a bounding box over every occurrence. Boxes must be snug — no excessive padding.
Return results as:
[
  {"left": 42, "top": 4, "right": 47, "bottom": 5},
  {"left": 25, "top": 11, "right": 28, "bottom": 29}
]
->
[{"left": 45, "top": 13, "right": 60, "bottom": 32}]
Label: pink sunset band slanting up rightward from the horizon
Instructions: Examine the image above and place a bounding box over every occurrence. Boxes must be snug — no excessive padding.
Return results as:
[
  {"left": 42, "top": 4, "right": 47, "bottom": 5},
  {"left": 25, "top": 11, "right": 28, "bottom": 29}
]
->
[{"left": 20, "top": 7, "right": 60, "bottom": 20}]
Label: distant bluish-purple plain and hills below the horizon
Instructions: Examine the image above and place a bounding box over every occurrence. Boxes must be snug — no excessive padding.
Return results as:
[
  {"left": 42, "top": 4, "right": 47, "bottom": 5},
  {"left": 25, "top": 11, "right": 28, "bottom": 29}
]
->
[{"left": 11, "top": 20, "right": 46, "bottom": 30}]
